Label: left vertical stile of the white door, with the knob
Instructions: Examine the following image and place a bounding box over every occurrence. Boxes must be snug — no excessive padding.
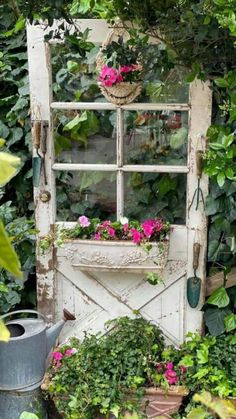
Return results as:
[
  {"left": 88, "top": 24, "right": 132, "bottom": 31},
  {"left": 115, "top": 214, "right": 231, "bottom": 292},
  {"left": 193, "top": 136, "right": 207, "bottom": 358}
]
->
[{"left": 27, "top": 25, "right": 56, "bottom": 321}]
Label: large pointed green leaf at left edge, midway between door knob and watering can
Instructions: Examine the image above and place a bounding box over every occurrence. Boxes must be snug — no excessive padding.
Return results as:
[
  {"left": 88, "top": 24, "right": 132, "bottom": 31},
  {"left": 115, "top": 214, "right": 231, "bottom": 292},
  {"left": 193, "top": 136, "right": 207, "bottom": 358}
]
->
[{"left": 0, "top": 221, "right": 22, "bottom": 278}]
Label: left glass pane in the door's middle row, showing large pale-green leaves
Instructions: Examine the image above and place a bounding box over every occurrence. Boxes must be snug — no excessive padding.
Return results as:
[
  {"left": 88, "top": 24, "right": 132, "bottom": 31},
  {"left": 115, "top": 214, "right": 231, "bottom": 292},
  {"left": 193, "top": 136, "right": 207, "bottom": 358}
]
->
[{"left": 53, "top": 111, "right": 116, "bottom": 164}]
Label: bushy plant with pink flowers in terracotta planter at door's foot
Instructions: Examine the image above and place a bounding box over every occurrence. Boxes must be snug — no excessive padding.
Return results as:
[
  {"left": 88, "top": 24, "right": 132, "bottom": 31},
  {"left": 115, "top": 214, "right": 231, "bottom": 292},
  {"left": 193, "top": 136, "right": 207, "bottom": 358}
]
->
[{"left": 43, "top": 317, "right": 187, "bottom": 419}]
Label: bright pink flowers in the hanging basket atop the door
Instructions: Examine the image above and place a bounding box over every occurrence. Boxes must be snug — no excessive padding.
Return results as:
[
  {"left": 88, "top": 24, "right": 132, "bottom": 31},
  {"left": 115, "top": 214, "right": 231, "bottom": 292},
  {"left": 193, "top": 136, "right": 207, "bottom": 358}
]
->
[{"left": 98, "top": 64, "right": 141, "bottom": 87}]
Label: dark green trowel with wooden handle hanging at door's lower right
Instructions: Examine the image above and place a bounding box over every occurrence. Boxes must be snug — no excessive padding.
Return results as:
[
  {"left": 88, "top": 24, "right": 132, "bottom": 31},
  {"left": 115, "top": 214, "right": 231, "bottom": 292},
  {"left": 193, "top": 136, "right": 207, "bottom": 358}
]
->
[{"left": 187, "top": 242, "right": 201, "bottom": 308}]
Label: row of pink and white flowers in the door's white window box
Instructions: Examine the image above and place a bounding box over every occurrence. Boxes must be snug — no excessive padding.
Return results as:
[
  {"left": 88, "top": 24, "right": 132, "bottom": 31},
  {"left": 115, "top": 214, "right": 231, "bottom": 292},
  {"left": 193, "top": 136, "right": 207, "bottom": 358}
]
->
[{"left": 73, "top": 215, "right": 170, "bottom": 244}]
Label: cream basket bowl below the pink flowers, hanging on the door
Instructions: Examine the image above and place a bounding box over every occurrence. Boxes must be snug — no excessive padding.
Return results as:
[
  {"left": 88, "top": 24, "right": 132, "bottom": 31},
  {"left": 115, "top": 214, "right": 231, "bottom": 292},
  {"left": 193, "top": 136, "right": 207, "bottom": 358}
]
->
[{"left": 99, "top": 82, "right": 142, "bottom": 106}]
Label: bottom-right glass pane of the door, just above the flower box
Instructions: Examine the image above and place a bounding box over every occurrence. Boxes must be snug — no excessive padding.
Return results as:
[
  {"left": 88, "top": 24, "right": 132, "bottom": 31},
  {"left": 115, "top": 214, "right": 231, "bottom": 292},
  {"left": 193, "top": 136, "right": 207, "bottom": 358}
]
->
[{"left": 124, "top": 172, "right": 187, "bottom": 224}]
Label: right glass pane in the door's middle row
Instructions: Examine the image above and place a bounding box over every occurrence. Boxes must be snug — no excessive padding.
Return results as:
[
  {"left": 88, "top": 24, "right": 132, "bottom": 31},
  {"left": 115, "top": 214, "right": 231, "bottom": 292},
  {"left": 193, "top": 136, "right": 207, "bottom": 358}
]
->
[{"left": 124, "top": 111, "right": 188, "bottom": 165}]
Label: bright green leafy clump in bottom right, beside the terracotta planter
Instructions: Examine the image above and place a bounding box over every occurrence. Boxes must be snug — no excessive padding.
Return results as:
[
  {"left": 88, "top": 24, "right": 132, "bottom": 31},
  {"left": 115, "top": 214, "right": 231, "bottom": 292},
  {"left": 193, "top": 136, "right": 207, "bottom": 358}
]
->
[{"left": 177, "top": 333, "right": 236, "bottom": 397}]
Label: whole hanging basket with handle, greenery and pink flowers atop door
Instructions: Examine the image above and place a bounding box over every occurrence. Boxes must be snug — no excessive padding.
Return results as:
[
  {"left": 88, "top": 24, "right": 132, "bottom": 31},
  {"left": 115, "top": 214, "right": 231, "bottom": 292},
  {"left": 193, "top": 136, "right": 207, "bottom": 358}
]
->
[{"left": 97, "top": 27, "right": 148, "bottom": 105}]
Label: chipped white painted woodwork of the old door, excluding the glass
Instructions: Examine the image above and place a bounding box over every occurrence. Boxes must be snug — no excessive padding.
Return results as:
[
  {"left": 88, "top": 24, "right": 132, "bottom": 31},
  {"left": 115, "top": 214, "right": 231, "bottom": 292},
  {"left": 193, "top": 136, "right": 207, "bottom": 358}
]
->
[{"left": 27, "top": 20, "right": 211, "bottom": 344}]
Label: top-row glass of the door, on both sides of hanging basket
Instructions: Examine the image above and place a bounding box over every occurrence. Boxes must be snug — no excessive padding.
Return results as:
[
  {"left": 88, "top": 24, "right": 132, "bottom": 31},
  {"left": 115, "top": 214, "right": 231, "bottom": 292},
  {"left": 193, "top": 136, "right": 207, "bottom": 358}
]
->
[{"left": 51, "top": 41, "right": 189, "bottom": 103}]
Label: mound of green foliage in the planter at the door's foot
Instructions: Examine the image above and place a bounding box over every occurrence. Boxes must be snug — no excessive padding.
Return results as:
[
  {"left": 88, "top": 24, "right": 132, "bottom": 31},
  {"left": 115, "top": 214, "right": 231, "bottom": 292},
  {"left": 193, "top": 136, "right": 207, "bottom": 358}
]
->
[{"left": 48, "top": 317, "right": 164, "bottom": 419}]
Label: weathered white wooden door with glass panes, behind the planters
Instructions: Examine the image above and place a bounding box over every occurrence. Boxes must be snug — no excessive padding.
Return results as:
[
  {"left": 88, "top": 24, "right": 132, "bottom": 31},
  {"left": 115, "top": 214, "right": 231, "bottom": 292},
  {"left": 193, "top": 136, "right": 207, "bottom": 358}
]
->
[{"left": 28, "top": 20, "right": 211, "bottom": 344}]
